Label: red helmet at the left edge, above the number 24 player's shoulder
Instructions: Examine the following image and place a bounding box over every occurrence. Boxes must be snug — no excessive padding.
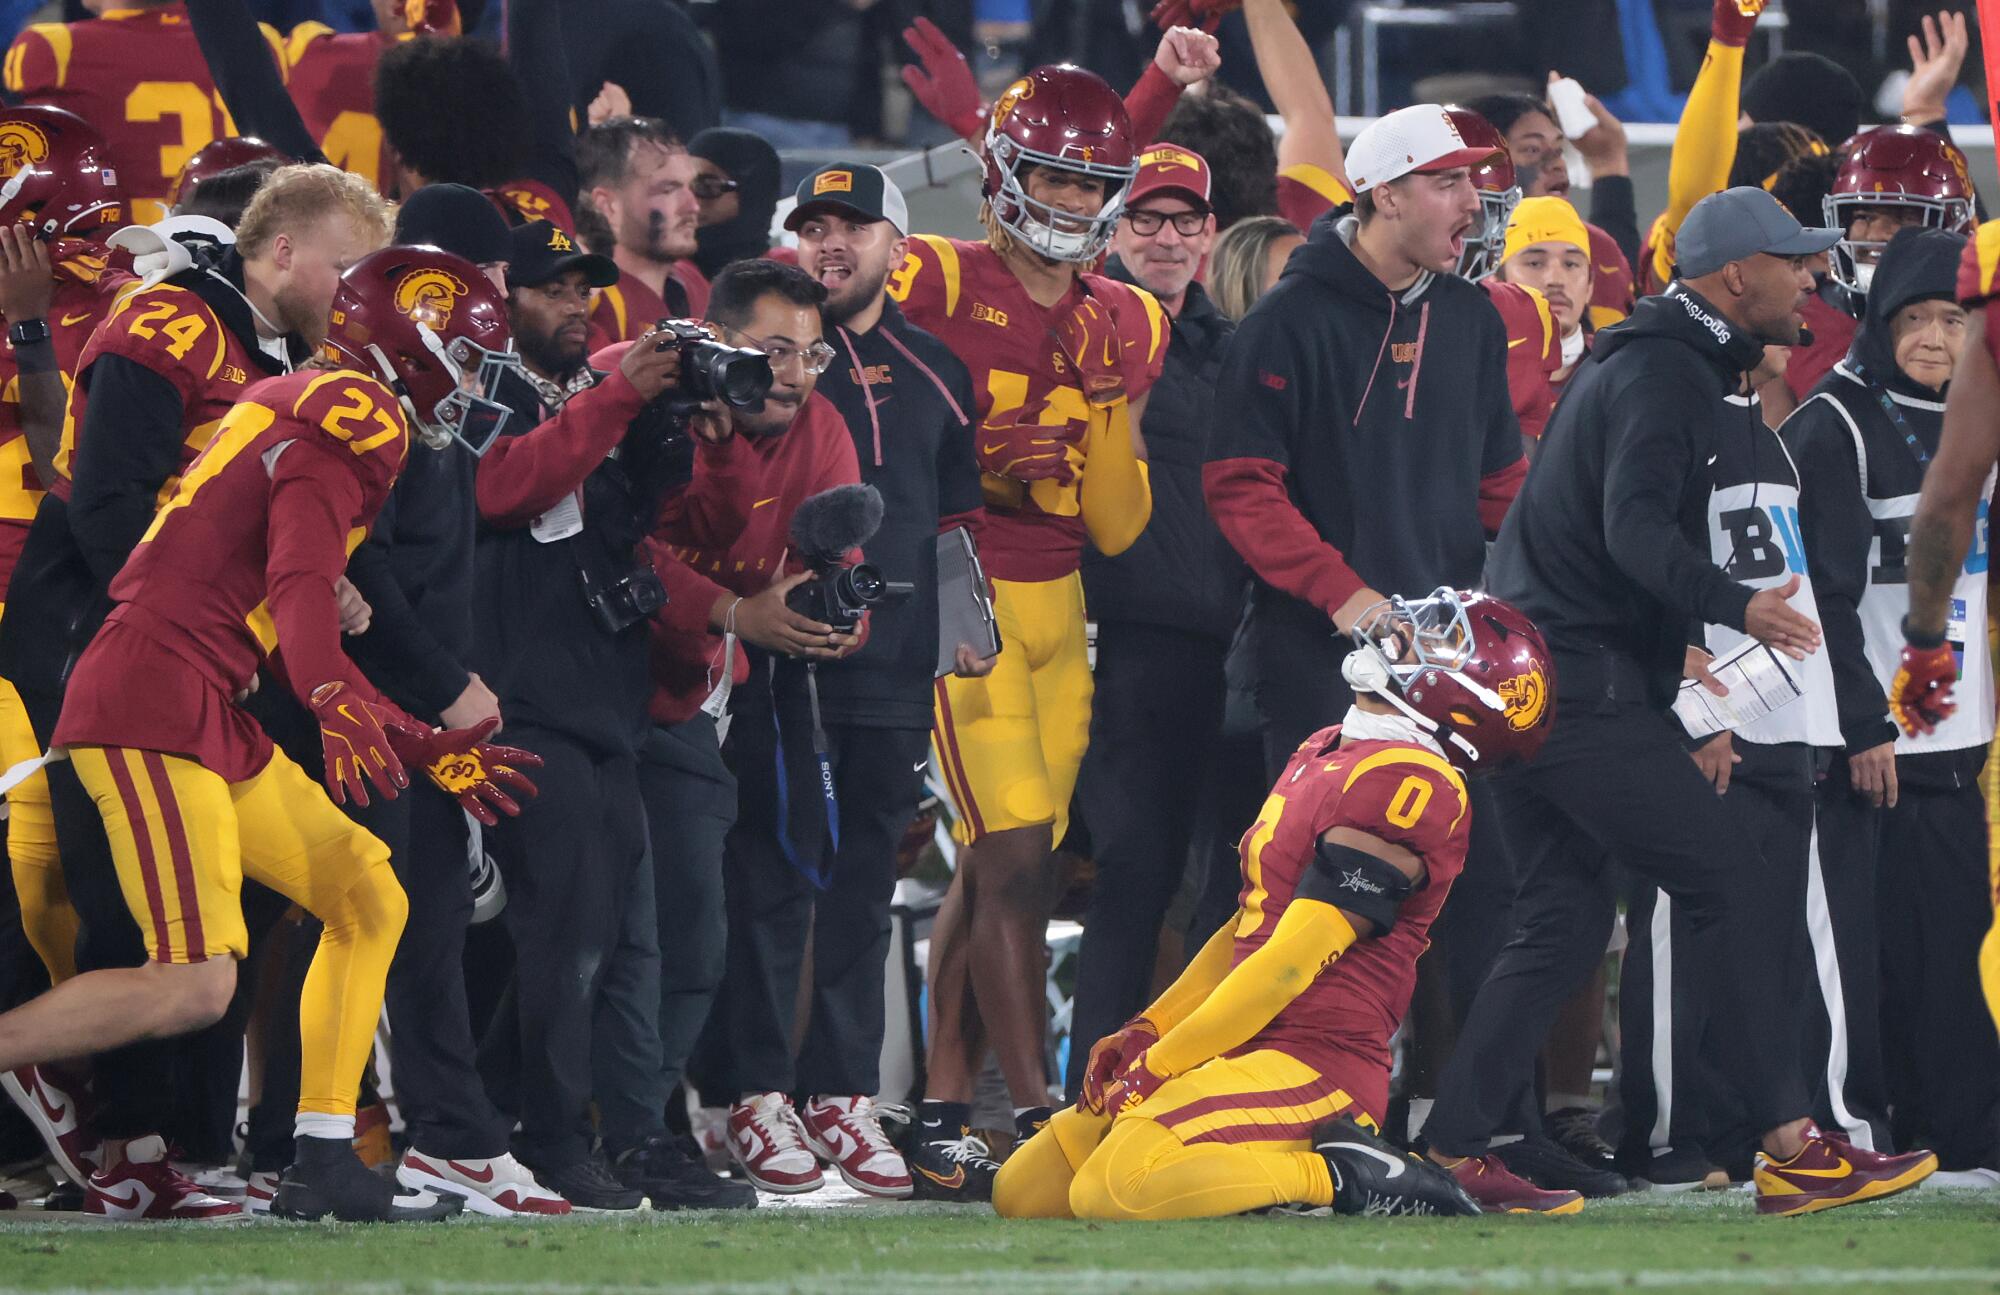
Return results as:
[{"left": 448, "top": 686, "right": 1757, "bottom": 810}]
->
[{"left": 0, "top": 104, "right": 122, "bottom": 238}]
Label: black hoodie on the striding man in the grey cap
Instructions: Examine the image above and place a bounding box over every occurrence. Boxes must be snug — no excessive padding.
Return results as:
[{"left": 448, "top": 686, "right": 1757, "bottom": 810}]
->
[{"left": 1486, "top": 282, "right": 1764, "bottom": 707}]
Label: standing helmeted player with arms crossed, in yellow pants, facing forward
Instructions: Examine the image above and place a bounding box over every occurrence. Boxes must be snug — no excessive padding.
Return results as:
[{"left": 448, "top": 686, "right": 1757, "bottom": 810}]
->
[{"left": 888, "top": 66, "right": 1170, "bottom": 1199}]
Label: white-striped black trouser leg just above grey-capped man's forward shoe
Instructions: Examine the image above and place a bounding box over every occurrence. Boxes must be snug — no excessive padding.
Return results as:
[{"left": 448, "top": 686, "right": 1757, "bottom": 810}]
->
[{"left": 1802, "top": 755, "right": 1888, "bottom": 1151}]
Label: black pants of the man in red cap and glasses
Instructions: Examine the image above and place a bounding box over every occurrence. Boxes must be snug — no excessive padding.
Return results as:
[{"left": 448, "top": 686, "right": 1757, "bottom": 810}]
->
[{"left": 1068, "top": 622, "right": 1246, "bottom": 1101}]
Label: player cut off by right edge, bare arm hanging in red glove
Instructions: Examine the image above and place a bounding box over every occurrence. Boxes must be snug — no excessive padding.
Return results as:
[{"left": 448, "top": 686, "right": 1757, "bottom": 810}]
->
[{"left": 1888, "top": 220, "right": 2000, "bottom": 1027}]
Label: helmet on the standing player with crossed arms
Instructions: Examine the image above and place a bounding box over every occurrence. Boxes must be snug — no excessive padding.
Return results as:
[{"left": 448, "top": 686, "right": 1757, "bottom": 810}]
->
[{"left": 982, "top": 64, "right": 1138, "bottom": 264}]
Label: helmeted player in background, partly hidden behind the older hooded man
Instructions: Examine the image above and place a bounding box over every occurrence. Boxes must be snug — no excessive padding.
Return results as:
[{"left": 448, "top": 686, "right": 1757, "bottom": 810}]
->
[{"left": 1784, "top": 126, "right": 1974, "bottom": 400}]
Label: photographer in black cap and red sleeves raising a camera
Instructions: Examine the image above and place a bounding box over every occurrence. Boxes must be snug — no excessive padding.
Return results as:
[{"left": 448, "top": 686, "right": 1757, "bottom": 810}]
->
[{"left": 474, "top": 222, "right": 750, "bottom": 1209}]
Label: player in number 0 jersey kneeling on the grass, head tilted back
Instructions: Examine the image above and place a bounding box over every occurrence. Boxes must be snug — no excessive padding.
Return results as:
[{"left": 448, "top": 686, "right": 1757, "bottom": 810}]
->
[{"left": 994, "top": 590, "right": 1552, "bottom": 1219}]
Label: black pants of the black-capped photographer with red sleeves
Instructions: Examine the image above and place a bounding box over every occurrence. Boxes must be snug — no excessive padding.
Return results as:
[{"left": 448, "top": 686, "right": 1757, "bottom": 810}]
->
[{"left": 480, "top": 727, "right": 650, "bottom": 1169}]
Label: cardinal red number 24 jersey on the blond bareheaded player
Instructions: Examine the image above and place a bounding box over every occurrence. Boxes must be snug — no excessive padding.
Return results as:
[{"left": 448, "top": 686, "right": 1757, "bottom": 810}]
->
[{"left": 50, "top": 282, "right": 264, "bottom": 504}]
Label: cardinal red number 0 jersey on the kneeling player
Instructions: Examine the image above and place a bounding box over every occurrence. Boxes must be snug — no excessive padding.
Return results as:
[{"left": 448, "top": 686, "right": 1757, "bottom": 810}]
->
[{"left": 1232, "top": 725, "right": 1472, "bottom": 1119}]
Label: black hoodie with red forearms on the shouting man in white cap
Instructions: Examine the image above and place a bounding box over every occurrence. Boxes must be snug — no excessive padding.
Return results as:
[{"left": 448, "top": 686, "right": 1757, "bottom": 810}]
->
[{"left": 1202, "top": 208, "right": 1526, "bottom": 616}]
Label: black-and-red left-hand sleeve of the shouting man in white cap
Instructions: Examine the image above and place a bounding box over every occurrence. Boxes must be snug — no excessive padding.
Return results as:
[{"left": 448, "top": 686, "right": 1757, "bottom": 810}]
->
[{"left": 1202, "top": 312, "right": 1364, "bottom": 616}]
